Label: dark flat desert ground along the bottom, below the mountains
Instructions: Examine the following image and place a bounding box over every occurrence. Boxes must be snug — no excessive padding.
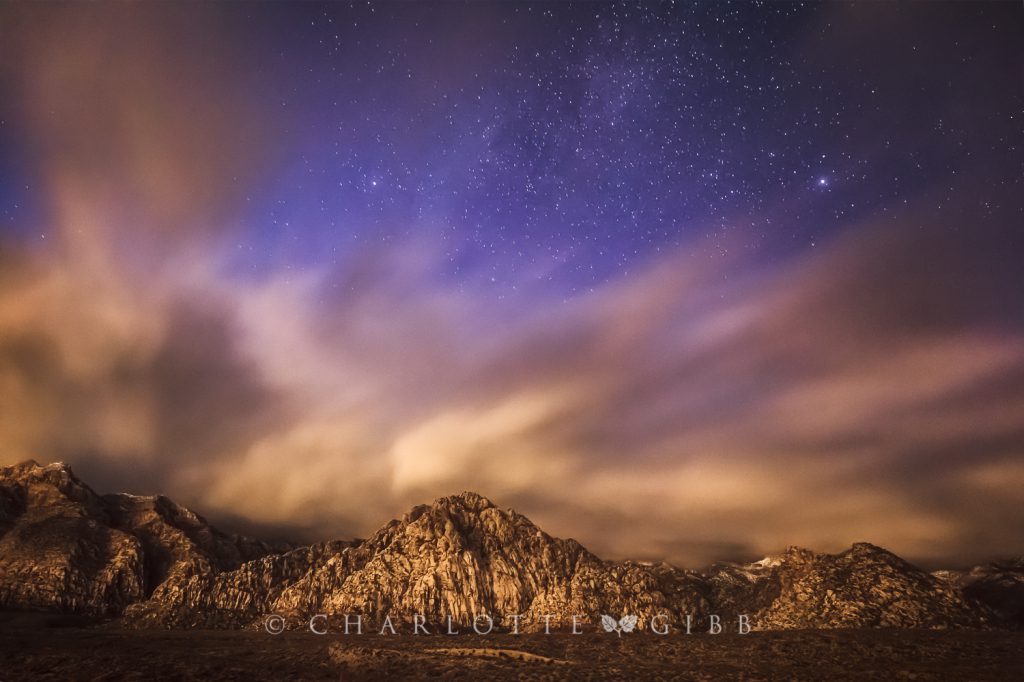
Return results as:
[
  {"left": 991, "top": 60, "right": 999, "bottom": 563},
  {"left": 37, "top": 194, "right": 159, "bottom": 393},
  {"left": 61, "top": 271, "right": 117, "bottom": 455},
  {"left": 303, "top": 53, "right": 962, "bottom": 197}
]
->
[{"left": 0, "top": 613, "right": 1024, "bottom": 682}]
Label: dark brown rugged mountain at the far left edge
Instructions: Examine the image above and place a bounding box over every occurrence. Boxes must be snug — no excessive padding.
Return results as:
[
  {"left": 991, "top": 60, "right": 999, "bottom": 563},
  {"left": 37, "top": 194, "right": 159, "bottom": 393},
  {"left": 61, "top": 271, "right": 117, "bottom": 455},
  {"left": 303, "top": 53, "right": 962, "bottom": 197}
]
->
[{"left": 0, "top": 461, "right": 273, "bottom": 615}]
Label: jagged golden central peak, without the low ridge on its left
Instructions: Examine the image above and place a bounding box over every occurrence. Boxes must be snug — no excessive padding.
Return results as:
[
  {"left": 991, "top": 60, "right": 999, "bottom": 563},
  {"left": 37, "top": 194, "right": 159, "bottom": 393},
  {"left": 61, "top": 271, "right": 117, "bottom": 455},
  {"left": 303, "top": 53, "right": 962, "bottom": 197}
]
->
[{"left": 273, "top": 493, "right": 707, "bottom": 630}]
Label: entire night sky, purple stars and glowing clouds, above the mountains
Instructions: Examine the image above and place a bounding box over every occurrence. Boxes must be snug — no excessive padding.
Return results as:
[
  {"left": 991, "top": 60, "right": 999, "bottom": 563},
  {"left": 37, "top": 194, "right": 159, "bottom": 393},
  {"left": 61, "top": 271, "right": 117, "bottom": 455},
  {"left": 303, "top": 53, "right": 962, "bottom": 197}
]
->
[{"left": 0, "top": 2, "right": 1024, "bottom": 567}]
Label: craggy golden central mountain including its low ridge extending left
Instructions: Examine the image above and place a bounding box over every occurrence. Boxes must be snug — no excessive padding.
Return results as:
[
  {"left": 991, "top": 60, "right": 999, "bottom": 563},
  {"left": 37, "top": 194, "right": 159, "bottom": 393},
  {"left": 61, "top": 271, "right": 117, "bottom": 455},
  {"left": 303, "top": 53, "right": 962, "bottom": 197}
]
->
[{"left": 126, "top": 493, "right": 710, "bottom": 631}]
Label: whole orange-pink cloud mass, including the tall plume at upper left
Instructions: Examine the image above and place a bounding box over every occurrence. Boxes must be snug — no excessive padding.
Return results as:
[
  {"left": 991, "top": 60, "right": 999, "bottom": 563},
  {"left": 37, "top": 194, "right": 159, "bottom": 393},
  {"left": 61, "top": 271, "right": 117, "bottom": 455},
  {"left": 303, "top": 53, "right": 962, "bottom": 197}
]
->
[{"left": 0, "top": 7, "right": 1024, "bottom": 565}]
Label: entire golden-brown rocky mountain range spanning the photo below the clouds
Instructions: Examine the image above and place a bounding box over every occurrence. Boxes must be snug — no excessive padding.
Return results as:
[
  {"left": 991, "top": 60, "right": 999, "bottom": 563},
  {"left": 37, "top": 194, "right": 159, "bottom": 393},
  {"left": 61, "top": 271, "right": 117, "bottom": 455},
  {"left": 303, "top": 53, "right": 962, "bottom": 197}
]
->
[{"left": 0, "top": 462, "right": 1024, "bottom": 631}]
